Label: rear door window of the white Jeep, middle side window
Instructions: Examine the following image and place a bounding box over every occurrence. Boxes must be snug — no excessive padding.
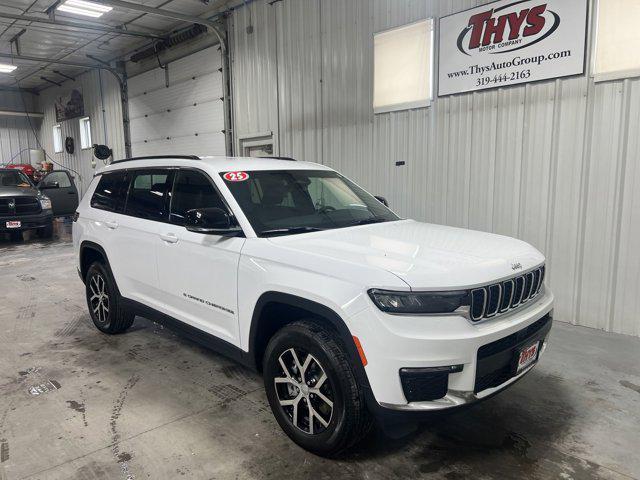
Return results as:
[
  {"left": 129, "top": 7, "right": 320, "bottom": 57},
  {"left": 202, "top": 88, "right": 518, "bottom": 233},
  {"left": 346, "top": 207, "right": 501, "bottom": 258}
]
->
[{"left": 125, "top": 169, "right": 173, "bottom": 220}]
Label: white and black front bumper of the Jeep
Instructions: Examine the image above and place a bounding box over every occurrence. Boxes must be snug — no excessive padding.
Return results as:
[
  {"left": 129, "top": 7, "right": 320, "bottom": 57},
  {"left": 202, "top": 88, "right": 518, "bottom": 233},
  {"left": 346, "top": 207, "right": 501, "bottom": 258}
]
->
[{"left": 350, "top": 290, "right": 553, "bottom": 413}]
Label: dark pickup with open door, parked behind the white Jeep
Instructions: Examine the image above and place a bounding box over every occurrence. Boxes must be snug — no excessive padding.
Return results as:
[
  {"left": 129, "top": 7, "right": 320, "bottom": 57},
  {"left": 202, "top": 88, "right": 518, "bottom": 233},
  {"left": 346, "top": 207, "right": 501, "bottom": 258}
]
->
[{"left": 0, "top": 168, "right": 78, "bottom": 240}]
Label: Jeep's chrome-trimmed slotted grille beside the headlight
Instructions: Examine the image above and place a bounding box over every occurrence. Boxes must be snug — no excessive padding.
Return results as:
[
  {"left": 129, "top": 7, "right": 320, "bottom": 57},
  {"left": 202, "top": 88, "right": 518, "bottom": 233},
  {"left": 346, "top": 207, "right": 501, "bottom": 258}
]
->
[{"left": 470, "top": 265, "right": 545, "bottom": 322}]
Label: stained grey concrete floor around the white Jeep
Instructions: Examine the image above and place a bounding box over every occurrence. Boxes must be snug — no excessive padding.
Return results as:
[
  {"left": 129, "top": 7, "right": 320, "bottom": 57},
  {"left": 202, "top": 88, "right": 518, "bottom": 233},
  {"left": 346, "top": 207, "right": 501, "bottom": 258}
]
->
[{"left": 0, "top": 223, "right": 640, "bottom": 480}]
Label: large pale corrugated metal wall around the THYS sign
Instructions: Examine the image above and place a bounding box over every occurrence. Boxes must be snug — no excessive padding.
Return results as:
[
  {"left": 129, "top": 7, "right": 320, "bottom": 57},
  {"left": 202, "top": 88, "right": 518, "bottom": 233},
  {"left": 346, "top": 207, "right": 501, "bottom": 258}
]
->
[{"left": 229, "top": 0, "right": 640, "bottom": 335}]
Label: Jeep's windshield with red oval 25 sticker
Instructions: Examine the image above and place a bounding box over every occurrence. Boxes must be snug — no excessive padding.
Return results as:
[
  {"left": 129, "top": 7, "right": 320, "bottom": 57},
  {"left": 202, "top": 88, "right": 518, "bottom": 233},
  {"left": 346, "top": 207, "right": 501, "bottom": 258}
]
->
[{"left": 220, "top": 170, "right": 399, "bottom": 236}]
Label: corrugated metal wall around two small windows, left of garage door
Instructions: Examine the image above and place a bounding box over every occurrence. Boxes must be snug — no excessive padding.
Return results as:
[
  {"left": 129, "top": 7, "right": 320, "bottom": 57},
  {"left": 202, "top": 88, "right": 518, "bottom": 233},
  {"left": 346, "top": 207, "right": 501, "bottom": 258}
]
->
[{"left": 39, "top": 70, "right": 125, "bottom": 194}]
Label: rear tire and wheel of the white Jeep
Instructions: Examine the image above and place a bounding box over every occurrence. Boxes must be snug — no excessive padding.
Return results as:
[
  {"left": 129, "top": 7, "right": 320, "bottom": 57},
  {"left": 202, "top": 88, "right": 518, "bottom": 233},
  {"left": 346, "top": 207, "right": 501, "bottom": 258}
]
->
[{"left": 85, "top": 262, "right": 135, "bottom": 335}]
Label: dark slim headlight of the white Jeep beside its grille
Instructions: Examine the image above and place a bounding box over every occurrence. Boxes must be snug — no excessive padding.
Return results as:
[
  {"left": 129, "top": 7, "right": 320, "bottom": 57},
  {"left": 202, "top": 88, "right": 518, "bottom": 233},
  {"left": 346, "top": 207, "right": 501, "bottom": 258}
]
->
[{"left": 369, "top": 289, "right": 469, "bottom": 314}]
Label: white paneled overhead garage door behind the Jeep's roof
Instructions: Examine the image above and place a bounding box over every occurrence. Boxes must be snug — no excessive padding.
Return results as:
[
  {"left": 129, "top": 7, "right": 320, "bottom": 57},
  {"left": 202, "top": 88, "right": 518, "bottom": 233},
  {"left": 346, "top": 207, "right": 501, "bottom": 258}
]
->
[{"left": 129, "top": 46, "right": 225, "bottom": 157}]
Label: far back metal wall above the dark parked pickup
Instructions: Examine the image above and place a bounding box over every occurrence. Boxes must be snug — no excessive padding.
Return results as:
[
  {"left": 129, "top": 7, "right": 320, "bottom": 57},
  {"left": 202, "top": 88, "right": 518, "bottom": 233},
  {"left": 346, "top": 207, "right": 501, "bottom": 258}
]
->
[{"left": 0, "top": 91, "right": 42, "bottom": 165}]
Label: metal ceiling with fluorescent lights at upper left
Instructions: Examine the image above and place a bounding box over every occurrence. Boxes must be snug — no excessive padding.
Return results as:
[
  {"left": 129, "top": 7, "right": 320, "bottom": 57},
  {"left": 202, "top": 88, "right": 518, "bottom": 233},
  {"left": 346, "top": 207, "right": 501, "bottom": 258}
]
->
[{"left": 0, "top": 0, "right": 231, "bottom": 91}]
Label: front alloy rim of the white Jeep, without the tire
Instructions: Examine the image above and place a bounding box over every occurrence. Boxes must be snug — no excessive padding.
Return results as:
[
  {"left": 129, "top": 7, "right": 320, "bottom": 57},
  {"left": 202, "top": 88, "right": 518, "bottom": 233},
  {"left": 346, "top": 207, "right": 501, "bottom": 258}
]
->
[{"left": 274, "top": 348, "right": 334, "bottom": 435}]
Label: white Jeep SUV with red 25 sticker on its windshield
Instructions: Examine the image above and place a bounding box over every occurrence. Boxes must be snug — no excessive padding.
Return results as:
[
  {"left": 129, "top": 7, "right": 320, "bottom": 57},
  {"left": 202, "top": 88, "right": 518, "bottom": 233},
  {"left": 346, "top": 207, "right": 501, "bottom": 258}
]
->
[{"left": 73, "top": 156, "right": 553, "bottom": 455}]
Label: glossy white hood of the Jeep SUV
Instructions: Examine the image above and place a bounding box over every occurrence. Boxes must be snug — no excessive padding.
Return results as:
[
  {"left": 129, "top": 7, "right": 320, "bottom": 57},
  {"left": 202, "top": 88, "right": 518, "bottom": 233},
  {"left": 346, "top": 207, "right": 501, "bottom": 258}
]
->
[{"left": 270, "top": 220, "right": 544, "bottom": 290}]
